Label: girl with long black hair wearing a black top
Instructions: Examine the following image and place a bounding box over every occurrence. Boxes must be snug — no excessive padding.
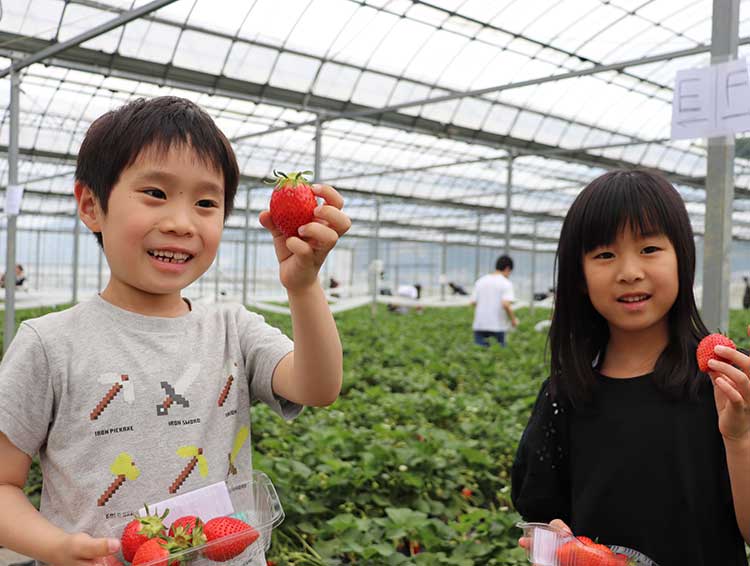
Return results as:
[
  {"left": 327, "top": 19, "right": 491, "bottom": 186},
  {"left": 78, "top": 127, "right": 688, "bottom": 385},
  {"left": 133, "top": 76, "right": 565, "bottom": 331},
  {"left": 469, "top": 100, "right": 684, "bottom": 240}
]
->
[{"left": 512, "top": 171, "right": 750, "bottom": 566}]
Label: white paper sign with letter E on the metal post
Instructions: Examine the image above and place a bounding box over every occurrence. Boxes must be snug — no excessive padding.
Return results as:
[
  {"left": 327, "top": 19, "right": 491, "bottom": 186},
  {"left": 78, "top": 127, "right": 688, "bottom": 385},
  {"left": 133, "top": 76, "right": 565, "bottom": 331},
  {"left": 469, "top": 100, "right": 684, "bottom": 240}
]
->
[{"left": 671, "top": 59, "right": 750, "bottom": 139}]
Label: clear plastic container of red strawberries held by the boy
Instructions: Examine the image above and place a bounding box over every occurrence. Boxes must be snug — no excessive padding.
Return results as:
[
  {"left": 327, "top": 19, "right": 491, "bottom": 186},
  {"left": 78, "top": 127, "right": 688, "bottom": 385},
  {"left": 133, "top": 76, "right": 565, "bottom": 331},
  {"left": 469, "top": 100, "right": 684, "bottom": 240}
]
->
[{"left": 110, "top": 471, "right": 284, "bottom": 566}]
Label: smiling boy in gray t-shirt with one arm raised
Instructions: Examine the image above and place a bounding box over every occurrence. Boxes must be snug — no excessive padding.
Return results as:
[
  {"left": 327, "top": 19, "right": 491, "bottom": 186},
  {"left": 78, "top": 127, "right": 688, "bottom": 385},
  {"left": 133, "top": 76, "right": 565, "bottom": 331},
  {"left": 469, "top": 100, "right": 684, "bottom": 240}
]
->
[{"left": 0, "top": 97, "right": 351, "bottom": 565}]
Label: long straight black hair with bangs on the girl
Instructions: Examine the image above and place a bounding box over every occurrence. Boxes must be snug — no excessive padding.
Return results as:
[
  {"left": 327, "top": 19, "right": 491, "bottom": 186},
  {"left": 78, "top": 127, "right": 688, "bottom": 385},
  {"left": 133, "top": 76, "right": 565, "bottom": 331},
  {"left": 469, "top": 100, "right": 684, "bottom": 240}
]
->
[{"left": 549, "top": 170, "right": 708, "bottom": 406}]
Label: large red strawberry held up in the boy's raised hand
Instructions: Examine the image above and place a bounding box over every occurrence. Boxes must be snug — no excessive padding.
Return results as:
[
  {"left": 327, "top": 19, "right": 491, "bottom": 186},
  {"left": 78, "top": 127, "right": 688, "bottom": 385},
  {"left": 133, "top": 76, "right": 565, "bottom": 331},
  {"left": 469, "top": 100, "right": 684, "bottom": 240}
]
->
[{"left": 269, "top": 170, "right": 318, "bottom": 238}]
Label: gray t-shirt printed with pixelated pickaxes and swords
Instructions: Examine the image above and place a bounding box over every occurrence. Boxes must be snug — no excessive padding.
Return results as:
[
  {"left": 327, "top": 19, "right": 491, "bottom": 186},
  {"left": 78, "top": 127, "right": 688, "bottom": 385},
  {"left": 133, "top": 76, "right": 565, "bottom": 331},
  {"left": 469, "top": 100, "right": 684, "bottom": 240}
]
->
[{"left": 0, "top": 296, "right": 301, "bottom": 536}]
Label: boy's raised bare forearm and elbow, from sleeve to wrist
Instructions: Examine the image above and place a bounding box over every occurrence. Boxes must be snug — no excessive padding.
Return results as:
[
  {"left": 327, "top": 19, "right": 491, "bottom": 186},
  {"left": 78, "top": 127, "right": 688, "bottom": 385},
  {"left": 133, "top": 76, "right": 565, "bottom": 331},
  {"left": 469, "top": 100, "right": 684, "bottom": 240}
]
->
[{"left": 273, "top": 284, "right": 343, "bottom": 407}]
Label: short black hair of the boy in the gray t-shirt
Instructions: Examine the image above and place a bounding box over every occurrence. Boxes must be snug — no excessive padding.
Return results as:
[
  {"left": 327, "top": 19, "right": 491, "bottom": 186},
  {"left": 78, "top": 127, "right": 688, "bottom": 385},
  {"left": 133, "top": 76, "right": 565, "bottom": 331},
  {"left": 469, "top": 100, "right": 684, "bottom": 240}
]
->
[{"left": 75, "top": 96, "right": 239, "bottom": 245}]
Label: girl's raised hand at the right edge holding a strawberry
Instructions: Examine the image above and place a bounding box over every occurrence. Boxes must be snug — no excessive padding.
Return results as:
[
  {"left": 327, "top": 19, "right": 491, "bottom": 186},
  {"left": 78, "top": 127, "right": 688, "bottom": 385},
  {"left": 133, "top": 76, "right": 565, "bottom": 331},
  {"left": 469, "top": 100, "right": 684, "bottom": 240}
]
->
[{"left": 708, "top": 326, "right": 750, "bottom": 442}]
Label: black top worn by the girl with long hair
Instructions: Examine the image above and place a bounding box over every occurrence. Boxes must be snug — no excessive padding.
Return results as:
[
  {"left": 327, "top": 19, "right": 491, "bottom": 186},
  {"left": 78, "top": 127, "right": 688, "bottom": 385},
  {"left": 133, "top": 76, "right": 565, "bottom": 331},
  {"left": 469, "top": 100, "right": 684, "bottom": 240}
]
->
[{"left": 512, "top": 374, "right": 747, "bottom": 566}]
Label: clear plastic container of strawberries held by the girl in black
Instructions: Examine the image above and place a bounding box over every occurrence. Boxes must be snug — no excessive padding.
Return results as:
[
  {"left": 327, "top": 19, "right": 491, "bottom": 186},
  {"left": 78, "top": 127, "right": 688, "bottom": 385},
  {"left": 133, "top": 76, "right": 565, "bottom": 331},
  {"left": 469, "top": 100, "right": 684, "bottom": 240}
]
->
[{"left": 516, "top": 523, "right": 658, "bottom": 566}]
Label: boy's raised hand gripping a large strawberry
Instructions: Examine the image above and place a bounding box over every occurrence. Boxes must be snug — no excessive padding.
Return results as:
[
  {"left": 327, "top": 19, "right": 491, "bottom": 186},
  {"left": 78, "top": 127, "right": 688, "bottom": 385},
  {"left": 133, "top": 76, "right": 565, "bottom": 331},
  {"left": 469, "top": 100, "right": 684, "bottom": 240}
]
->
[{"left": 258, "top": 184, "right": 352, "bottom": 291}]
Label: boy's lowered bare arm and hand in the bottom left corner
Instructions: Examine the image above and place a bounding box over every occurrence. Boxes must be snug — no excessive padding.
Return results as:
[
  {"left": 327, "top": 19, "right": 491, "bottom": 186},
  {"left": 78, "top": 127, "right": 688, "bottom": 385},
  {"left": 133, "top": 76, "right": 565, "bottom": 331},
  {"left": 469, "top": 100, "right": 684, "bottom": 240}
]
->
[{"left": 0, "top": 433, "right": 120, "bottom": 565}]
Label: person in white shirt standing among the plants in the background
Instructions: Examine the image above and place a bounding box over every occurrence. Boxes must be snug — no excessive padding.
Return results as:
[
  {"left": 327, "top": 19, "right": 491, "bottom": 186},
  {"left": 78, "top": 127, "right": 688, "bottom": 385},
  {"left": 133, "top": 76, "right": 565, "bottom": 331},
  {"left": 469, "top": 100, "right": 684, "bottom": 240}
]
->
[{"left": 471, "top": 255, "right": 518, "bottom": 347}]
